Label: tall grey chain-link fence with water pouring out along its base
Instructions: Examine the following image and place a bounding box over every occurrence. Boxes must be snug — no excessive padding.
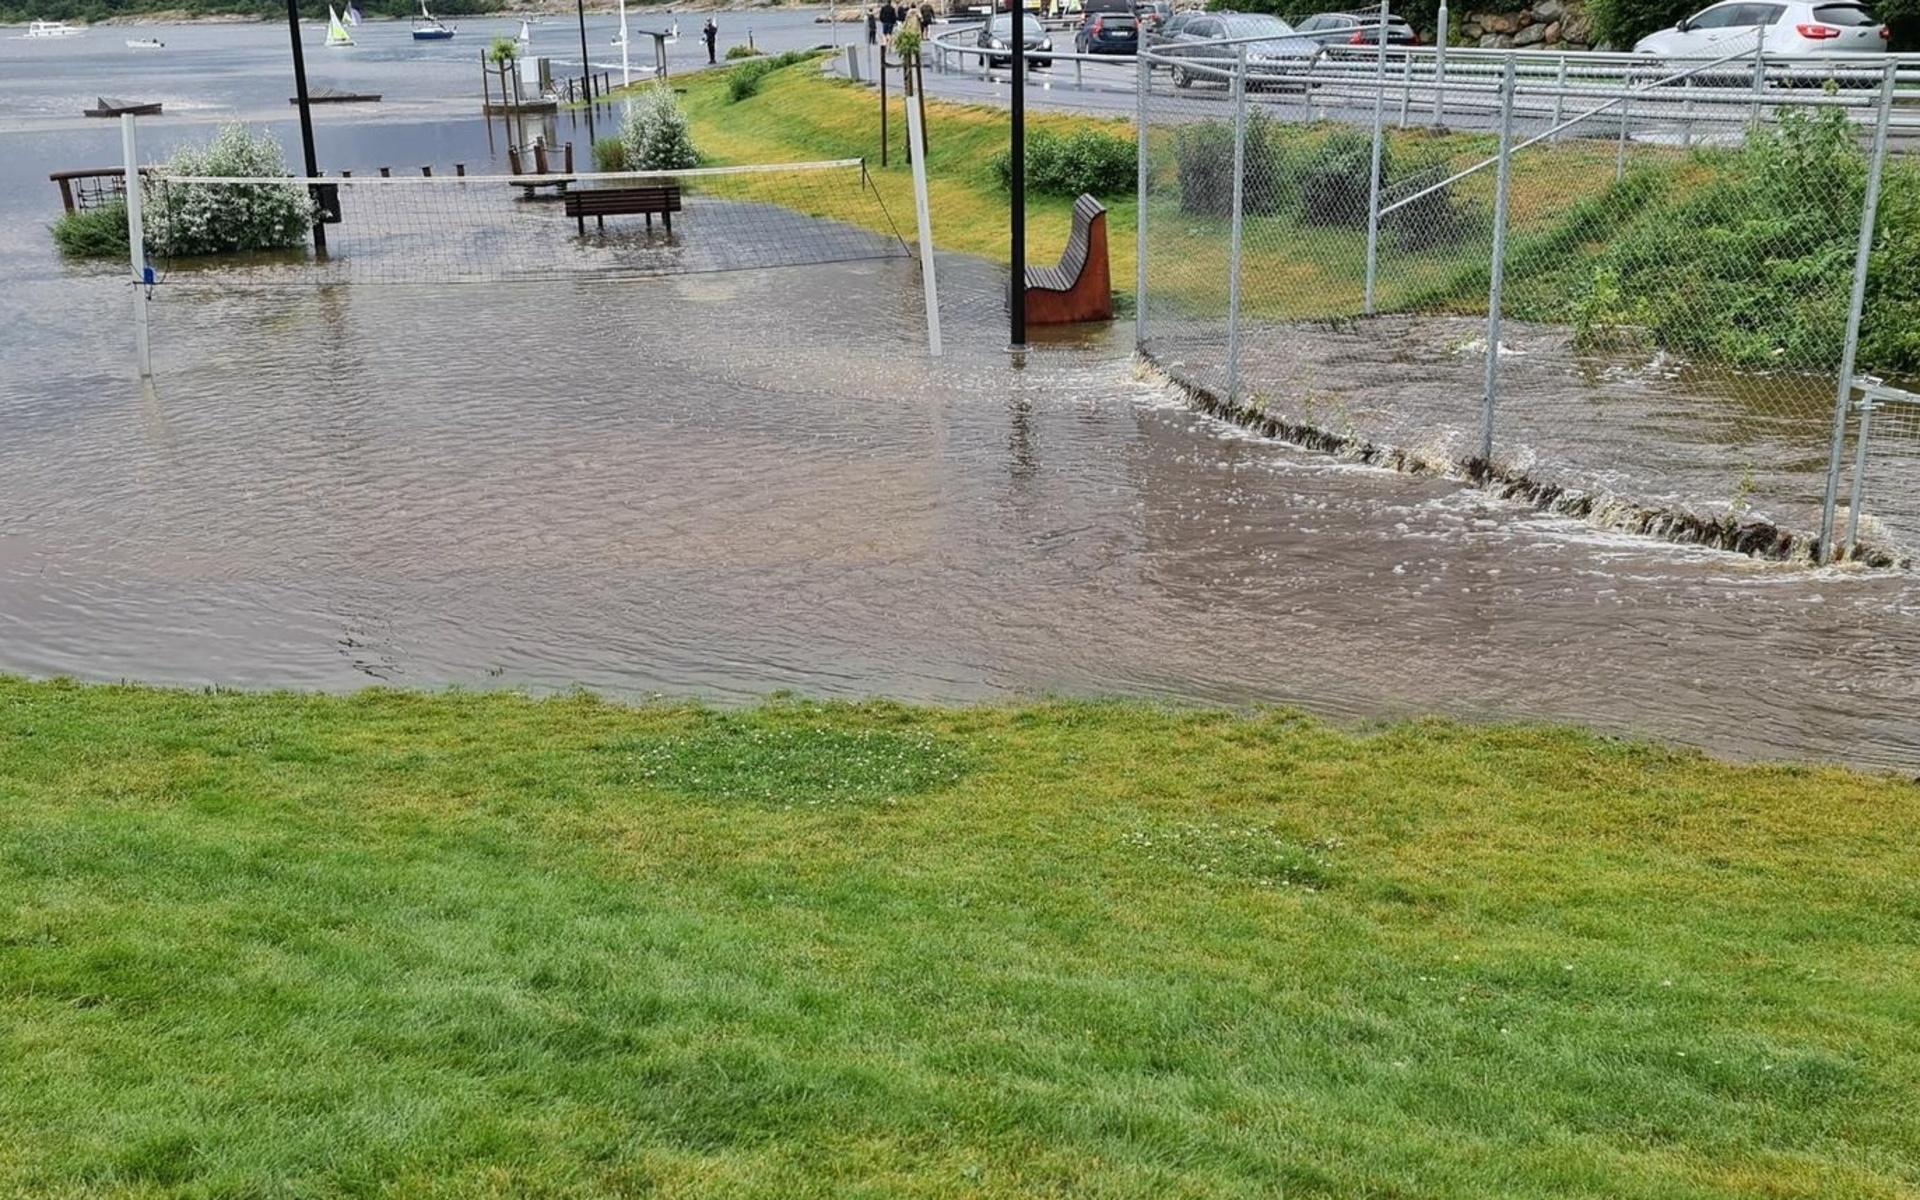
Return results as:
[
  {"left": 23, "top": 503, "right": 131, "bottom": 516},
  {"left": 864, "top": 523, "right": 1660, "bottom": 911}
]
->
[{"left": 1137, "top": 42, "right": 1920, "bottom": 563}]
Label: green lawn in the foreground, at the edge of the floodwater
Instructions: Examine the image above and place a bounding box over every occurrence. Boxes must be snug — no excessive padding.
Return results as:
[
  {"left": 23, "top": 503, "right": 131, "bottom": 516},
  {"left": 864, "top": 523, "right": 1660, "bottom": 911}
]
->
[{"left": 0, "top": 680, "right": 1920, "bottom": 1200}]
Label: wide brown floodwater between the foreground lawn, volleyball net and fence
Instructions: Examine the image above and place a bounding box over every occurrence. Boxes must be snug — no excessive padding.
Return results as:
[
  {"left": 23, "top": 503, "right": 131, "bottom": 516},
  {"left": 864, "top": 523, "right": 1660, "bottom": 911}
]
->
[{"left": 0, "top": 42, "right": 1920, "bottom": 770}]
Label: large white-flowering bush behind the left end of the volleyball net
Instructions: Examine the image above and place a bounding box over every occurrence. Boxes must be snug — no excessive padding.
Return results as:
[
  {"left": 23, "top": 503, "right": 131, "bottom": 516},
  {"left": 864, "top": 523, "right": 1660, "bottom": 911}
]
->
[{"left": 148, "top": 125, "right": 313, "bottom": 257}]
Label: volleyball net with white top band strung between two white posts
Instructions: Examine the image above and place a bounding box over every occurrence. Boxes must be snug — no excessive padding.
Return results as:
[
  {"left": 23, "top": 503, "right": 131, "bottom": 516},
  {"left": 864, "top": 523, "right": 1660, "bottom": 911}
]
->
[{"left": 144, "top": 159, "right": 910, "bottom": 288}]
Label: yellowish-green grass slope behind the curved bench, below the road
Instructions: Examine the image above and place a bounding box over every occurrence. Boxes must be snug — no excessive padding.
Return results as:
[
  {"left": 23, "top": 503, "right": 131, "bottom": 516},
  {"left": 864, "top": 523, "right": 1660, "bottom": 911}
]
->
[{"left": 656, "top": 63, "right": 1651, "bottom": 319}]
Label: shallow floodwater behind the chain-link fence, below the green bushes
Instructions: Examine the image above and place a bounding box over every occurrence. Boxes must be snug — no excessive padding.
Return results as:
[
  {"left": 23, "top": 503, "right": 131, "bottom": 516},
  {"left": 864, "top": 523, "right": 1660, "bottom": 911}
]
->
[{"left": 1150, "top": 313, "right": 1920, "bottom": 561}]
